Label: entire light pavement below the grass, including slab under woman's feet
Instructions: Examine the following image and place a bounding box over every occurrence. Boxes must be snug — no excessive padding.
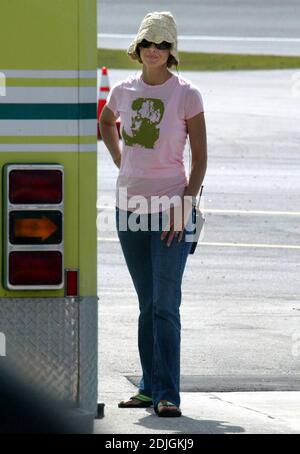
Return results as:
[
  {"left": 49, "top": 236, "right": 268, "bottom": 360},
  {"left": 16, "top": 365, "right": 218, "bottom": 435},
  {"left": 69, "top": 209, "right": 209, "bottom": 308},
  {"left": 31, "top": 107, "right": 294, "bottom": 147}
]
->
[{"left": 95, "top": 67, "right": 300, "bottom": 434}]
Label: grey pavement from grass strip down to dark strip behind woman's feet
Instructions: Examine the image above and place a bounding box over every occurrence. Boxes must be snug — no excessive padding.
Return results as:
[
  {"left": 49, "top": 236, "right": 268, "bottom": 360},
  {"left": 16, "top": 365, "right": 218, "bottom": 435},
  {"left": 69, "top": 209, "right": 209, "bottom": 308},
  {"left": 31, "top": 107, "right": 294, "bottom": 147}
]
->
[{"left": 98, "top": 70, "right": 300, "bottom": 389}]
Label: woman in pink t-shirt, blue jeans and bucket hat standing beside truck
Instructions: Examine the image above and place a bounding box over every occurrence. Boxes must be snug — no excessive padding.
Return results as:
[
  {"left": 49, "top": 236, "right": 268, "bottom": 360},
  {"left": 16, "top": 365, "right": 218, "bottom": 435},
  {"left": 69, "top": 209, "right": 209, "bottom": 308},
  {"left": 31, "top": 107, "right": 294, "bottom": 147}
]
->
[{"left": 100, "top": 12, "right": 207, "bottom": 416}]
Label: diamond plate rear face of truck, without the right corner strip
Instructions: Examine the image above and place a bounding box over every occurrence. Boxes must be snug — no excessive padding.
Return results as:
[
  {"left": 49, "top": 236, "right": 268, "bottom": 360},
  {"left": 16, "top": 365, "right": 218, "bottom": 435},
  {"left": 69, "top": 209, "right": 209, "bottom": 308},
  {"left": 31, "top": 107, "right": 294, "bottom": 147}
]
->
[{"left": 0, "top": 298, "right": 79, "bottom": 403}]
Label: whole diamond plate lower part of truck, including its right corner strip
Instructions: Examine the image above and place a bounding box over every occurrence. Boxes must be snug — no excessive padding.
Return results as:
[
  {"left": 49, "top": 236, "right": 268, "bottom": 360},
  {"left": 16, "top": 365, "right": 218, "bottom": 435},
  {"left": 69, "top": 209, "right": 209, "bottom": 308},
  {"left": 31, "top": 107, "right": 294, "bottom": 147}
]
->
[{"left": 0, "top": 297, "right": 98, "bottom": 414}]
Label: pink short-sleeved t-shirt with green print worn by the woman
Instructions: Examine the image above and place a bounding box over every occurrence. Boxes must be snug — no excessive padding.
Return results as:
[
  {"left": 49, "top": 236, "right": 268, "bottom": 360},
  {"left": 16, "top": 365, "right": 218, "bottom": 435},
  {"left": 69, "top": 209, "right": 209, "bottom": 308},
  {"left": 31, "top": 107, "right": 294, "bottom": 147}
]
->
[{"left": 107, "top": 74, "right": 204, "bottom": 213}]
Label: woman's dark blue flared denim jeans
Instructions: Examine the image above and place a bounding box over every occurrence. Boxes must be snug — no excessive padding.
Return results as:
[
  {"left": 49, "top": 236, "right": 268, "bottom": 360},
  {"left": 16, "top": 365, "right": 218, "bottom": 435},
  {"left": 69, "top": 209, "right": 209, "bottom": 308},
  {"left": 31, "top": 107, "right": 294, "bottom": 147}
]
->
[{"left": 116, "top": 208, "right": 191, "bottom": 406}]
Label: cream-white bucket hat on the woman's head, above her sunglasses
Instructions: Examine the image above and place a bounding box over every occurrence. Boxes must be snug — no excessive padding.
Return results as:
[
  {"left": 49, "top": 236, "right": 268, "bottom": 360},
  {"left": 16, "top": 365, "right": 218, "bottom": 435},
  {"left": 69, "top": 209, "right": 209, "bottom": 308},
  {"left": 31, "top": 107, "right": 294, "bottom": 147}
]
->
[{"left": 127, "top": 11, "right": 179, "bottom": 64}]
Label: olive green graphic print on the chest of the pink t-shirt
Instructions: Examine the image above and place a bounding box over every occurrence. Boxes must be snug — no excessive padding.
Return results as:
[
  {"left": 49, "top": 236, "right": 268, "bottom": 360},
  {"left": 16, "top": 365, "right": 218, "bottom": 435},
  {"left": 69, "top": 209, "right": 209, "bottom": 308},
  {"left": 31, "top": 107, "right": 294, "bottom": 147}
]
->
[{"left": 122, "top": 98, "right": 165, "bottom": 148}]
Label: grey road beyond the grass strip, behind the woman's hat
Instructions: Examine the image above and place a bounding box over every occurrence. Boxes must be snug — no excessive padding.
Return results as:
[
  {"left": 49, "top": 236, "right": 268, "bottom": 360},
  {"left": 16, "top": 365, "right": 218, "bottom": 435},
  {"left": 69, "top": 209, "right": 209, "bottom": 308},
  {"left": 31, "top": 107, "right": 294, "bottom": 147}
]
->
[{"left": 98, "top": 0, "right": 300, "bottom": 55}]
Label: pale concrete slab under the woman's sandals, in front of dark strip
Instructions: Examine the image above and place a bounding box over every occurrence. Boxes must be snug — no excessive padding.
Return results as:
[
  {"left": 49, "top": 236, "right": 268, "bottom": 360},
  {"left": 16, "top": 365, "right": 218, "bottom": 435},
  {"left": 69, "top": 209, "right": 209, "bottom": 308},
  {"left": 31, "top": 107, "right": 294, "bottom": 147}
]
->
[{"left": 95, "top": 392, "right": 300, "bottom": 434}]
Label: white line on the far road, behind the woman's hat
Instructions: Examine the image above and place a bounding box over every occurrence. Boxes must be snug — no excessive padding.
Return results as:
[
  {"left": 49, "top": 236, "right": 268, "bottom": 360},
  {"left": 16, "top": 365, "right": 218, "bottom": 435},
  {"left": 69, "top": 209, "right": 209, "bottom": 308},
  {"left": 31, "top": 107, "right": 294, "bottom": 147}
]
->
[{"left": 98, "top": 33, "right": 300, "bottom": 43}]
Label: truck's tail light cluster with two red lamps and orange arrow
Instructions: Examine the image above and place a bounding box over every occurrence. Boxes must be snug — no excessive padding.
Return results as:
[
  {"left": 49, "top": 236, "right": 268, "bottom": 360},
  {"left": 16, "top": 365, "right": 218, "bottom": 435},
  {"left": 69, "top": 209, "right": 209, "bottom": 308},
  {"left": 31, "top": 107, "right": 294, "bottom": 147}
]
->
[{"left": 3, "top": 164, "right": 64, "bottom": 290}]
